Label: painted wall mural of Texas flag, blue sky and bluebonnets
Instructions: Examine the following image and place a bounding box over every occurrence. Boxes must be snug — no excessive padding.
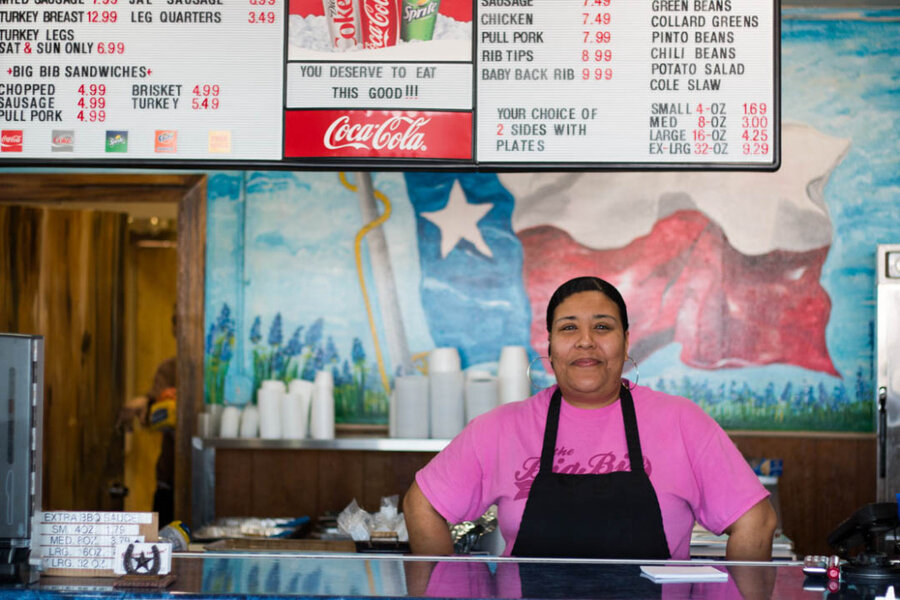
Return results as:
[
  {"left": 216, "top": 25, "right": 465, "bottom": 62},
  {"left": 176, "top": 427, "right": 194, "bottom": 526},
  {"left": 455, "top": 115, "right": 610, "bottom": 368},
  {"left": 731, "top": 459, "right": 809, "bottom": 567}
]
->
[{"left": 206, "top": 10, "right": 900, "bottom": 431}]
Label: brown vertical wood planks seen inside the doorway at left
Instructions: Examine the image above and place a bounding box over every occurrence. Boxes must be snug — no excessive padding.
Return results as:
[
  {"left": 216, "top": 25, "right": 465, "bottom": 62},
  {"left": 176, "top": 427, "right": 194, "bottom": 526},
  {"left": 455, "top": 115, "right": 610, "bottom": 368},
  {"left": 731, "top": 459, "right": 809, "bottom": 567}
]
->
[{"left": 0, "top": 206, "right": 126, "bottom": 510}]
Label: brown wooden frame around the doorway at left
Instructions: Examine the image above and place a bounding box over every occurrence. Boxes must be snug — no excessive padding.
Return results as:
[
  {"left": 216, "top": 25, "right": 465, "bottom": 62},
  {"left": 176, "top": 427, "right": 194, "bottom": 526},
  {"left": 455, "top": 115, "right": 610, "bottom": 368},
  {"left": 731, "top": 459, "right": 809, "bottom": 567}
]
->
[{"left": 0, "top": 171, "right": 207, "bottom": 526}]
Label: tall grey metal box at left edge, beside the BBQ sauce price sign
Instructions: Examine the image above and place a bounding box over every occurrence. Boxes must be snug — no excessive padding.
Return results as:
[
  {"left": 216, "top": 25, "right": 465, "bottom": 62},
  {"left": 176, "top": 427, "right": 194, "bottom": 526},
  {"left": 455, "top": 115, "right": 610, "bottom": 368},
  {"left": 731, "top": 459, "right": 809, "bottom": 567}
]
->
[{"left": 0, "top": 333, "right": 44, "bottom": 579}]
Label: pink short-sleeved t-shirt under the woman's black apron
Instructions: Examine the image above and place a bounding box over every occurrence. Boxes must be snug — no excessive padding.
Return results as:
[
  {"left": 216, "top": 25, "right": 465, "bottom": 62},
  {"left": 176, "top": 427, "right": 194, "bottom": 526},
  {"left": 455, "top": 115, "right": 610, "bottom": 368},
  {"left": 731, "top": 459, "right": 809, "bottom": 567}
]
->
[{"left": 416, "top": 386, "right": 768, "bottom": 559}]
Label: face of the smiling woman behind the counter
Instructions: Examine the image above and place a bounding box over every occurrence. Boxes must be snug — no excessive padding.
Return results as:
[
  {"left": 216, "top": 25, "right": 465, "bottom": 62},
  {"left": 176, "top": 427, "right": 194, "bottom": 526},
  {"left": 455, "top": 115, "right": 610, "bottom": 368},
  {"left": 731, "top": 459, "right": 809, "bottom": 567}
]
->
[{"left": 550, "top": 291, "right": 628, "bottom": 408}]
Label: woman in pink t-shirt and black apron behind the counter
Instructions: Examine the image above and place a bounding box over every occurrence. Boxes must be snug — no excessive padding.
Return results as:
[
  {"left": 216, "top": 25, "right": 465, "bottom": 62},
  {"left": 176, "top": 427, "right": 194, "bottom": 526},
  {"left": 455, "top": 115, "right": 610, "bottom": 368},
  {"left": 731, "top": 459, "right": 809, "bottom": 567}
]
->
[{"left": 403, "top": 277, "right": 776, "bottom": 560}]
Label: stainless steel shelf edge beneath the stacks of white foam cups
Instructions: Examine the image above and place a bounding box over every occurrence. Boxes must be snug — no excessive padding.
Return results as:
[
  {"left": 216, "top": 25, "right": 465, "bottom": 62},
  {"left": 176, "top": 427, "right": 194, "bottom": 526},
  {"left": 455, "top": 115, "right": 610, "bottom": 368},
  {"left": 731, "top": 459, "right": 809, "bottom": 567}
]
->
[{"left": 192, "top": 436, "right": 450, "bottom": 452}]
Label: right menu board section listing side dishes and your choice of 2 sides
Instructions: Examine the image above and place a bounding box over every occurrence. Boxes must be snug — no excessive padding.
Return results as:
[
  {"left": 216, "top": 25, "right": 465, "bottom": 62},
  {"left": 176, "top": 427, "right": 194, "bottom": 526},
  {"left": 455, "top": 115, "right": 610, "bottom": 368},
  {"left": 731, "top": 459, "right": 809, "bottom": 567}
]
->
[{"left": 477, "top": 0, "right": 777, "bottom": 164}]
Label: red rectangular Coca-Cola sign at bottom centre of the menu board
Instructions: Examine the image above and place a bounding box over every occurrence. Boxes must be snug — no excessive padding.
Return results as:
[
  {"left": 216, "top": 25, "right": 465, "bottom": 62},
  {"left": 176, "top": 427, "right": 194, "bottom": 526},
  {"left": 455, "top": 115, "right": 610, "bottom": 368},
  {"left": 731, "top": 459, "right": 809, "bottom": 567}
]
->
[{"left": 285, "top": 110, "right": 472, "bottom": 159}]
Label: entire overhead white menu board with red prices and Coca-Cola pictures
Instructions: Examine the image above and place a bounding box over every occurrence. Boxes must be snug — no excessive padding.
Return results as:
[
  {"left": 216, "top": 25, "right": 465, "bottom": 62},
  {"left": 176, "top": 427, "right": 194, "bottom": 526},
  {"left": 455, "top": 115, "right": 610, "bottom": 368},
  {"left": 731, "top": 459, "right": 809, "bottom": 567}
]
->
[{"left": 0, "top": 0, "right": 780, "bottom": 170}]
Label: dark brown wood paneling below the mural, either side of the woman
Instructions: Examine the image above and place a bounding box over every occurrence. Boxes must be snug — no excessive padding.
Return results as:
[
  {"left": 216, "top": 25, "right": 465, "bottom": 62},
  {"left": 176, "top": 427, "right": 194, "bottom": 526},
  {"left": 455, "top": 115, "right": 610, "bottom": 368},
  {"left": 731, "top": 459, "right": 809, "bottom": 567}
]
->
[{"left": 215, "top": 432, "right": 875, "bottom": 555}]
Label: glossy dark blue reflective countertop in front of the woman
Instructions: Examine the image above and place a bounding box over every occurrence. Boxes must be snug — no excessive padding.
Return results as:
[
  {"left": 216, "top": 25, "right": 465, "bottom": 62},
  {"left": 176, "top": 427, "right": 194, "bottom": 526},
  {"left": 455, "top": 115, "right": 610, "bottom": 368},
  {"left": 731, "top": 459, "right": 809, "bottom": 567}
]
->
[{"left": 0, "top": 552, "right": 886, "bottom": 600}]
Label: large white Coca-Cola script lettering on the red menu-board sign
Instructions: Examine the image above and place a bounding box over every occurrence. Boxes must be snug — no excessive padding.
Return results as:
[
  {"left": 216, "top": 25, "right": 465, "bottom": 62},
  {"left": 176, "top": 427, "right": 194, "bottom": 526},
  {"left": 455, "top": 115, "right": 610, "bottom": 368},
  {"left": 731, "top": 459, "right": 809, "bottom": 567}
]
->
[{"left": 323, "top": 115, "right": 431, "bottom": 151}]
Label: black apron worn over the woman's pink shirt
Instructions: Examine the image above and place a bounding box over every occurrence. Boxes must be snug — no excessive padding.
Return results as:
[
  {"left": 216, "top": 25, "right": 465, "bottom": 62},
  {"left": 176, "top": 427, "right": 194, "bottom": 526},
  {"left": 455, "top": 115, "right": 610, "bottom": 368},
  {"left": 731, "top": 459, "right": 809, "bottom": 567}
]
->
[{"left": 512, "top": 384, "right": 670, "bottom": 559}]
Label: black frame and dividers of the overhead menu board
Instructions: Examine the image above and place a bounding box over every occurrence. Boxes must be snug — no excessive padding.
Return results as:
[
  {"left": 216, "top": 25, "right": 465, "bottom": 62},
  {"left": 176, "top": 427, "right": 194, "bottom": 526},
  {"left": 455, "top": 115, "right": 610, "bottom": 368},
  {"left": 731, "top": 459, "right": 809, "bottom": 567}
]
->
[{"left": 0, "top": 0, "right": 782, "bottom": 172}]
